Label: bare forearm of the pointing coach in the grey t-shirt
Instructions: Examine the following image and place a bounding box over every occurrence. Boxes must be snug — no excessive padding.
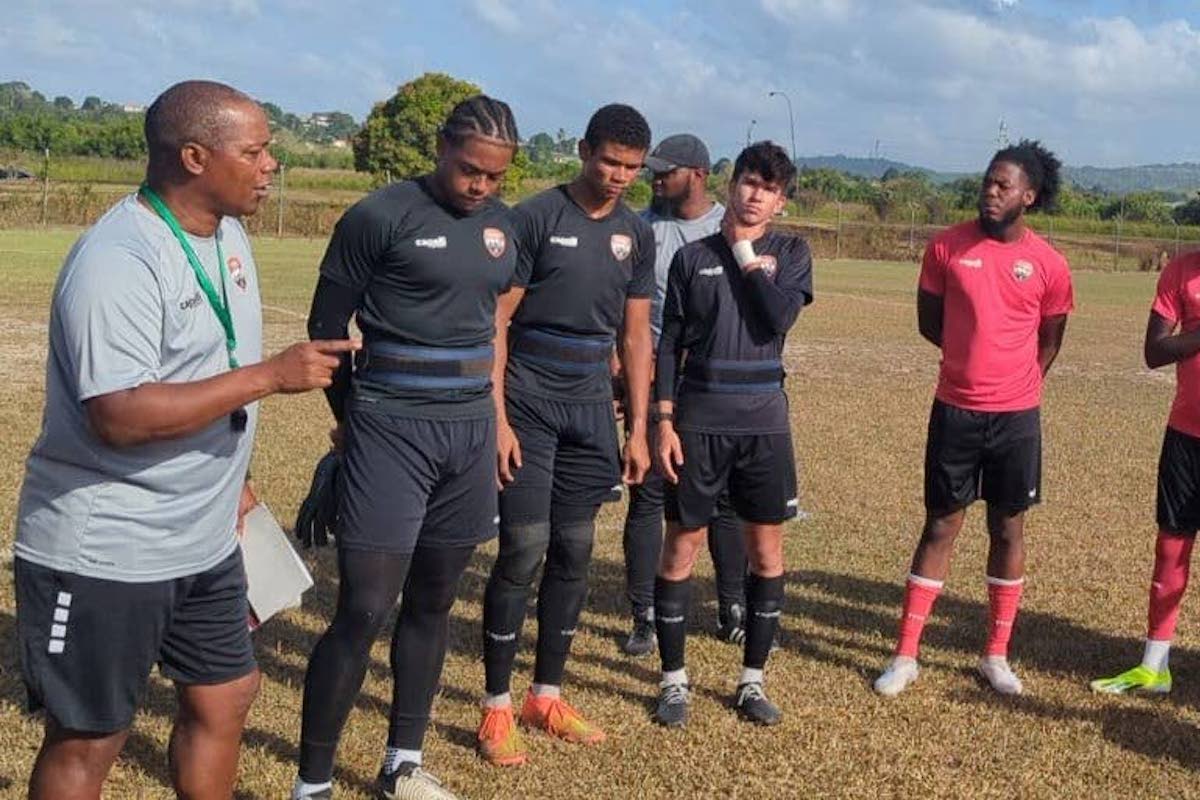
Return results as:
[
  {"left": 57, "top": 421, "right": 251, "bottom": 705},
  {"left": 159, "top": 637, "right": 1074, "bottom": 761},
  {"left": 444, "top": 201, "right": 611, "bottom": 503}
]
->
[{"left": 86, "top": 362, "right": 278, "bottom": 447}]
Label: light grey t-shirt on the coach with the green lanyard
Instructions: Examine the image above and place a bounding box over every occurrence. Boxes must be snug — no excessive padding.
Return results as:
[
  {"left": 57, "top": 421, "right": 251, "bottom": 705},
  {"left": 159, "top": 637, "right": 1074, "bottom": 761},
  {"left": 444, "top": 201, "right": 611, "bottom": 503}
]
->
[{"left": 14, "top": 196, "right": 263, "bottom": 583}]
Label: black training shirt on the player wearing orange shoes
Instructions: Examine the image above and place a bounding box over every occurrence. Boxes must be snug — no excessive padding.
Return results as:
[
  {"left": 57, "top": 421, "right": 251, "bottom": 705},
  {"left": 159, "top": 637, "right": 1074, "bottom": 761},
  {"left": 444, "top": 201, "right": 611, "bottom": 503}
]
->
[{"left": 505, "top": 185, "right": 654, "bottom": 401}]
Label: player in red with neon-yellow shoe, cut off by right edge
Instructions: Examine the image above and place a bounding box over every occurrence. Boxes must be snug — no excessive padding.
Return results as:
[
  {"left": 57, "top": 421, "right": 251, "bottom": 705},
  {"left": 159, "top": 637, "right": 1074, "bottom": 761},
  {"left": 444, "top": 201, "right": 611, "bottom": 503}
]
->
[{"left": 1091, "top": 253, "right": 1200, "bottom": 694}]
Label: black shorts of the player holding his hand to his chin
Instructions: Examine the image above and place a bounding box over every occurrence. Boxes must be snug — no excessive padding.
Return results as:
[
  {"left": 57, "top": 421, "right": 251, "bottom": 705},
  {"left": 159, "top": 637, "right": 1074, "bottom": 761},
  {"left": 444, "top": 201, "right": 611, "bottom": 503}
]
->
[{"left": 664, "top": 431, "right": 800, "bottom": 528}]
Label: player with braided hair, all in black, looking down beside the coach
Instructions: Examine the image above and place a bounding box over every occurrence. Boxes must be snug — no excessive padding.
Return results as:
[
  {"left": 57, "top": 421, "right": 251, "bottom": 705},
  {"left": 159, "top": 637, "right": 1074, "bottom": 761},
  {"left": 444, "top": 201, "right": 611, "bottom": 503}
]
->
[{"left": 293, "top": 95, "right": 518, "bottom": 800}]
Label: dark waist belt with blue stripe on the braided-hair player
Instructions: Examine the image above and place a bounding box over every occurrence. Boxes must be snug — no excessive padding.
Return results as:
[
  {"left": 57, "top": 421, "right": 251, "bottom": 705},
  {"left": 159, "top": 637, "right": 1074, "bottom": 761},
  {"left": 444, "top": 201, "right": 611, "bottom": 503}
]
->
[{"left": 356, "top": 342, "right": 492, "bottom": 389}]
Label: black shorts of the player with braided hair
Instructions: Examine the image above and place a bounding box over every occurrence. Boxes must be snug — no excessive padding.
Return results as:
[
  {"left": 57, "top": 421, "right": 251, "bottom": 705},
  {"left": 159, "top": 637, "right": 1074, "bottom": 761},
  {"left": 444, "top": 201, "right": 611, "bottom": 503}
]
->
[{"left": 337, "top": 408, "right": 499, "bottom": 555}]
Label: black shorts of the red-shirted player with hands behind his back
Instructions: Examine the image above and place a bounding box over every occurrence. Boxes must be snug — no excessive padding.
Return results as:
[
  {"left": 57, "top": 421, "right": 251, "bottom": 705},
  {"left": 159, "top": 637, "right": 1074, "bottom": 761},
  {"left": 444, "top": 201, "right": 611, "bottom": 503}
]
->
[{"left": 925, "top": 399, "right": 1042, "bottom": 517}]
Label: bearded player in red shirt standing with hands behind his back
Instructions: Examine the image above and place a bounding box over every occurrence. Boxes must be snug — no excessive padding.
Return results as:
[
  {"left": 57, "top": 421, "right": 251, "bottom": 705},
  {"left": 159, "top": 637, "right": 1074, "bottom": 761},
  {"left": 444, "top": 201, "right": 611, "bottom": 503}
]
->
[{"left": 875, "top": 140, "right": 1074, "bottom": 697}]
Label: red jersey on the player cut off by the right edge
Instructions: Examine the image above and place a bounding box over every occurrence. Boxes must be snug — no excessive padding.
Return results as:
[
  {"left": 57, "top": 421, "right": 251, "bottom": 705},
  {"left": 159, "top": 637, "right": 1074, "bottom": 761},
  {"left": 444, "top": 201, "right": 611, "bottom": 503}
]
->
[{"left": 1151, "top": 253, "right": 1200, "bottom": 437}]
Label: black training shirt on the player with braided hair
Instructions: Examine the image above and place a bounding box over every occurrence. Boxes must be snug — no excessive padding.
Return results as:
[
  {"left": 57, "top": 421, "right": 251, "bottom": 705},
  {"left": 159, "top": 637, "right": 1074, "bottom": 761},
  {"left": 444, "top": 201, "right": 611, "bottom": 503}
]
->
[{"left": 320, "top": 178, "right": 516, "bottom": 417}]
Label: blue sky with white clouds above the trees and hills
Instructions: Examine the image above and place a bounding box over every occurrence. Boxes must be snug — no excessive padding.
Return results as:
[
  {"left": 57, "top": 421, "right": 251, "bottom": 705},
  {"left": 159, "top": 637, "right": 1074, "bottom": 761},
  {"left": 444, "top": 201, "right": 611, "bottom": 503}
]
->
[{"left": 0, "top": 0, "right": 1200, "bottom": 172}]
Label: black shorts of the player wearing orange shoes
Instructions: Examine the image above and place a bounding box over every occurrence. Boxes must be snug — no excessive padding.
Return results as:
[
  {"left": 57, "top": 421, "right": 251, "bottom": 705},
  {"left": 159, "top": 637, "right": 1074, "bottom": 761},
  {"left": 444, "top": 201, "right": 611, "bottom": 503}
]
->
[{"left": 500, "top": 392, "right": 620, "bottom": 522}]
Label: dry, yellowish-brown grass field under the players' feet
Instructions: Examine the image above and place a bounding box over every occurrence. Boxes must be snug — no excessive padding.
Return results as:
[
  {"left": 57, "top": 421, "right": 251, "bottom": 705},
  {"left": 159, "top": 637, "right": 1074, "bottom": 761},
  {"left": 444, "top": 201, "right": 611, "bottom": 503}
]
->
[{"left": 0, "top": 230, "right": 1200, "bottom": 799}]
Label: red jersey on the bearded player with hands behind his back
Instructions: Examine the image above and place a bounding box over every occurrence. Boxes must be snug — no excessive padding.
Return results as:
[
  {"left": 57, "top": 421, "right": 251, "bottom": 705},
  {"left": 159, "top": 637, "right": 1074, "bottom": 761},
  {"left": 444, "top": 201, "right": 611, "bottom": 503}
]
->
[{"left": 919, "top": 221, "right": 1075, "bottom": 411}]
